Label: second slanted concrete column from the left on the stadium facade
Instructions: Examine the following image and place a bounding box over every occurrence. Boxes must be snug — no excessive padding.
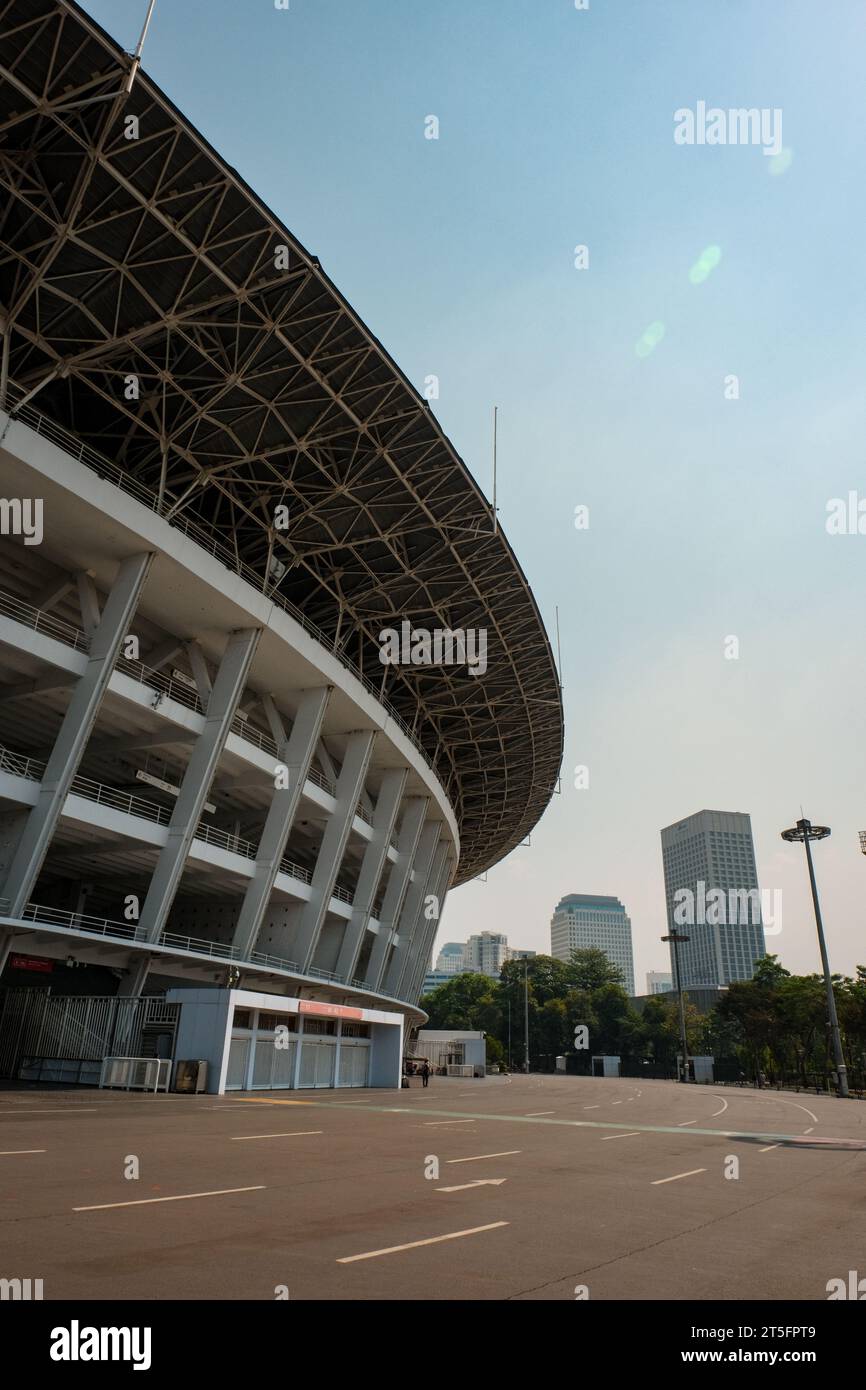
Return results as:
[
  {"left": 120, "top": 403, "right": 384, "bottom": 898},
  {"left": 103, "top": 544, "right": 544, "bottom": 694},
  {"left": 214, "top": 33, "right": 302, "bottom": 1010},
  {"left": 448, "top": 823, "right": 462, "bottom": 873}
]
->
[{"left": 139, "top": 628, "right": 260, "bottom": 941}]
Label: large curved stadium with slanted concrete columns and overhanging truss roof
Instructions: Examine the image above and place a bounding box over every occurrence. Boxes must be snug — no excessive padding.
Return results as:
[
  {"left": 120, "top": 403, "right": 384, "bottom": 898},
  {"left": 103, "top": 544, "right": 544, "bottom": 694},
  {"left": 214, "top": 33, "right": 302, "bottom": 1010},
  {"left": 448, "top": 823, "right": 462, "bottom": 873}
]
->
[{"left": 0, "top": 0, "right": 563, "bottom": 1091}]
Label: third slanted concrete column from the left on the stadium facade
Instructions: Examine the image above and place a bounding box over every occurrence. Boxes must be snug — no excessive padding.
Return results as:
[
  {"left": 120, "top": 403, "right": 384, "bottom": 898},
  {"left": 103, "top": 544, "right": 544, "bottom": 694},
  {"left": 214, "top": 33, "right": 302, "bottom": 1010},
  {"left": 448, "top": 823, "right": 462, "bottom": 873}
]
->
[{"left": 234, "top": 685, "right": 331, "bottom": 958}]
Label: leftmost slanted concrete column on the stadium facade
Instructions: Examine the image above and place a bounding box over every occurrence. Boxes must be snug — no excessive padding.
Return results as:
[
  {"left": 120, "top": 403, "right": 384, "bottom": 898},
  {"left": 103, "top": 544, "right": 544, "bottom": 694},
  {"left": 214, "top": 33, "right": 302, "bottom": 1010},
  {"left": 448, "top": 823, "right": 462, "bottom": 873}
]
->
[{"left": 3, "top": 555, "right": 153, "bottom": 917}]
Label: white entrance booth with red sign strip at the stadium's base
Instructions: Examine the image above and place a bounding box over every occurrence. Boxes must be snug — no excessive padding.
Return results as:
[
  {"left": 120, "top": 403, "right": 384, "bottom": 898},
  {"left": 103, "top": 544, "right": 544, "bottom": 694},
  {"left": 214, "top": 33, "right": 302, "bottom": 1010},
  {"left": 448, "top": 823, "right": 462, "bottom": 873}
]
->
[{"left": 167, "top": 988, "right": 403, "bottom": 1095}]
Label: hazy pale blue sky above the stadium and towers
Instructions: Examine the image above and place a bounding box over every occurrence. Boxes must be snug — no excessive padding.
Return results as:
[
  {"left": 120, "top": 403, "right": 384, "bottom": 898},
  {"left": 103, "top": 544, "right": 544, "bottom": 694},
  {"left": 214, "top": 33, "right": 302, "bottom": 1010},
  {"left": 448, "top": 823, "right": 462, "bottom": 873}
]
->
[{"left": 86, "top": 0, "right": 866, "bottom": 988}]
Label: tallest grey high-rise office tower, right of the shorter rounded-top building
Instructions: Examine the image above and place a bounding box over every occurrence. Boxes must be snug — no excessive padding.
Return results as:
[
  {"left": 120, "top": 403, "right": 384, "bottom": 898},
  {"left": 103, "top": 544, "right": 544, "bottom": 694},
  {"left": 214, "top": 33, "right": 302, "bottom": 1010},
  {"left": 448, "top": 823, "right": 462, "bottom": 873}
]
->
[{"left": 662, "top": 810, "right": 766, "bottom": 988}]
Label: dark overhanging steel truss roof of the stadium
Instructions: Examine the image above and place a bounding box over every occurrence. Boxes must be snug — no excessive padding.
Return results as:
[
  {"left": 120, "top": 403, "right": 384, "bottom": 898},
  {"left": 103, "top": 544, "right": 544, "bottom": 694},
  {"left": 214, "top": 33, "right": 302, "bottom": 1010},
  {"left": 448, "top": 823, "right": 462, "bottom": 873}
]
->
[{"left": 0, "top": 0, "right": 563, "bottom": 883}]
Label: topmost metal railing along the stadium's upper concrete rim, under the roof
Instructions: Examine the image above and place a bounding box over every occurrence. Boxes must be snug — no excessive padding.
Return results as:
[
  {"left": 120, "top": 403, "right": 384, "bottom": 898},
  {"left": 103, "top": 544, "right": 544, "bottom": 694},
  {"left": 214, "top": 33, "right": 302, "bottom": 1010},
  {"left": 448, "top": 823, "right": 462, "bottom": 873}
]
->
[{"left": 8, "top": 381, "right": 438, "bottom": 776}]
